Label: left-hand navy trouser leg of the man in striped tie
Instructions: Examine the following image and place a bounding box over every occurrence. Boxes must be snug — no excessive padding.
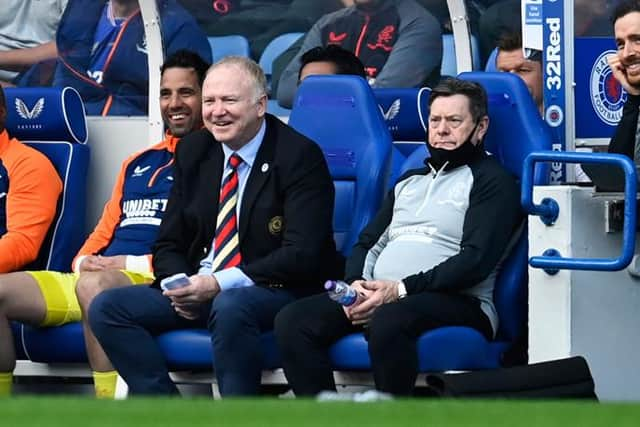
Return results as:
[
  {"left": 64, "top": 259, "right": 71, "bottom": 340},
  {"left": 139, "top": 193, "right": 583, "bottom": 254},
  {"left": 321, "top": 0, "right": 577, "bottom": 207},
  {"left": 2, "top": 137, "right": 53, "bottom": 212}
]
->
[{"left": 88, "top": 286, "right": 191, "bottom": 394}]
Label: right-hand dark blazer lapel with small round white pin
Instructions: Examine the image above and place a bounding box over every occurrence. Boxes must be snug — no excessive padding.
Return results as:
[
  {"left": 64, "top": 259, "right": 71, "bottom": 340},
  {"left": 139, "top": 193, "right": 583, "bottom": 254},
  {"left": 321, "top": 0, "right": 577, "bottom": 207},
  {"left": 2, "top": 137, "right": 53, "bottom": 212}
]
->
[{"left": 238, "top": 116, "right": 277, "bottom": 244}]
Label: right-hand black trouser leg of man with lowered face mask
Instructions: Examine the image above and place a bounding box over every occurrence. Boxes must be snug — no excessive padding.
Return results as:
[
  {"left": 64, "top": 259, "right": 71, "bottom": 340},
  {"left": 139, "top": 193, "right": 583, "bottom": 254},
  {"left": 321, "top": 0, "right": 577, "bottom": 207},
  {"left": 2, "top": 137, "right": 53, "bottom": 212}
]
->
[{"left": 369, "top": 292, "right": 493, "bottom": 395}]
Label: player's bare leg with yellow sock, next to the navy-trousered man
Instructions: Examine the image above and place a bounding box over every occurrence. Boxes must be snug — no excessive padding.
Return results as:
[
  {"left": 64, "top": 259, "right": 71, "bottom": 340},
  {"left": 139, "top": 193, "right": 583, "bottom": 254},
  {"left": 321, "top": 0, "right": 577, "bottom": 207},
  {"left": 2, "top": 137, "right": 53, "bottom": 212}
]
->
[{"left": 76, "top": 270, "right": 153, "bottom": 398}]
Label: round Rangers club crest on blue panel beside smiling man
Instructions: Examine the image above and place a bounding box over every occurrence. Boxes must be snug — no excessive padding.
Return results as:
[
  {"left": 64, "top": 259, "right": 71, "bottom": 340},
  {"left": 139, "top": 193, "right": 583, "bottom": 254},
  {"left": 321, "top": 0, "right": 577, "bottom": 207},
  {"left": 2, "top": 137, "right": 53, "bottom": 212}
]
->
[{"left": 589, "top": 50, "right": 627, "bottom": 126}]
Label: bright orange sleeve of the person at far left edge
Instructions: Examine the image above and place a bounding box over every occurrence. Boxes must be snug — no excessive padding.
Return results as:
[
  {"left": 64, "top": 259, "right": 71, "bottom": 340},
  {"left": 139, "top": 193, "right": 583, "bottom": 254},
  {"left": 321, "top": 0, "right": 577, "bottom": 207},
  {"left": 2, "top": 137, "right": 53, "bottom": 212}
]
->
[{"left": 0, "top": 138, "right": 62, "bottom": 273}]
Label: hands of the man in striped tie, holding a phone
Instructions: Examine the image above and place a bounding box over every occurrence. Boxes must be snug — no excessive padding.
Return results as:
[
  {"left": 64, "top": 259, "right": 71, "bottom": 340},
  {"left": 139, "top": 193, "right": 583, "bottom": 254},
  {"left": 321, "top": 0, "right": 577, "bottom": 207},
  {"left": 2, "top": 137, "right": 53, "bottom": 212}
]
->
[{"left": 162, "top": 274, "right": 220, "bottom": 320}]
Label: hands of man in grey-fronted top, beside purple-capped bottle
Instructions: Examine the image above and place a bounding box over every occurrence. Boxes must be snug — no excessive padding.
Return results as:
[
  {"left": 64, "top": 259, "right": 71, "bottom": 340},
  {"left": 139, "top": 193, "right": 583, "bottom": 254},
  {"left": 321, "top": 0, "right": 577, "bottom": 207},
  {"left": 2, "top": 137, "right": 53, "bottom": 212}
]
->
[{"left": 343, "top": 280, "right": 398, "bottom": 325}]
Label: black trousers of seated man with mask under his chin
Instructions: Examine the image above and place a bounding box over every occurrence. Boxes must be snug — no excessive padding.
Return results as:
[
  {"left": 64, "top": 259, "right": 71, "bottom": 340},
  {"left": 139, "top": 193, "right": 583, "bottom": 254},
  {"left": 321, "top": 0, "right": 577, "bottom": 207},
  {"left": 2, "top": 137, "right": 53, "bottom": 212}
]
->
[{"left": 275, "top": 292, "right": 493, "bottom": 396}]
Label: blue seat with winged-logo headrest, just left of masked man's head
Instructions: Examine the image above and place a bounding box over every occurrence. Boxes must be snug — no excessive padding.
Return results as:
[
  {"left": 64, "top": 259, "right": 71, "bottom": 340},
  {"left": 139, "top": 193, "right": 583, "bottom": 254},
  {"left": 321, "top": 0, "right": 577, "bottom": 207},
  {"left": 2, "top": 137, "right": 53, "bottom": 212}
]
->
[{"left": 373, "top": 87, "right": 431, "bottom": 189}]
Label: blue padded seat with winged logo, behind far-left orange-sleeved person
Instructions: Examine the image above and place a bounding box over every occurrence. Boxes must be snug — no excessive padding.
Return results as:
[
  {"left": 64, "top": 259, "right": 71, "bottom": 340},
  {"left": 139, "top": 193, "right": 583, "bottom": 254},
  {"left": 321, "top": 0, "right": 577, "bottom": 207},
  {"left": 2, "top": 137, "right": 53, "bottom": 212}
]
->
[{"left": 5, "top": 88, "right": 89, "bottom": 368}]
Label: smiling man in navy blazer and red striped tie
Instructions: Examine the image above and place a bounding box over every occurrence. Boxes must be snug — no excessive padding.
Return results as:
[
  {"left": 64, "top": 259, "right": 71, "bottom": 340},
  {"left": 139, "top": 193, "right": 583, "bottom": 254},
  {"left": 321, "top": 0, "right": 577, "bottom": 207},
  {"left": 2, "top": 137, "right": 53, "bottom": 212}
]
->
[{"left": 89, "top": 57, "right": 340, "bottom": 396}]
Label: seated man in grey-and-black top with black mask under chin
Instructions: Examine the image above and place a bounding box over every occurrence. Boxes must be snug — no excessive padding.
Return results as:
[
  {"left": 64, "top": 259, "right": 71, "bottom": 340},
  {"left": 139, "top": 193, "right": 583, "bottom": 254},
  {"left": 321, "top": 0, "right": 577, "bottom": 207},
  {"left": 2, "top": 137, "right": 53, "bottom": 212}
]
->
[{"left": 275, "top": 79, "right": 523, "bottom": 396}]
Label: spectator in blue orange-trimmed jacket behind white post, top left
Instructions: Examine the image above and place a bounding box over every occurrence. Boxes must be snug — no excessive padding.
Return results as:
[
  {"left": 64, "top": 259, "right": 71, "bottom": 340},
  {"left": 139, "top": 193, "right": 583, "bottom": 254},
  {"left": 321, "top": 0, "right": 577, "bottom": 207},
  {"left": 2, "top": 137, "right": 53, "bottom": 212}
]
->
[{"left": 53, "top": 0, "right": 211, "bottom": 116}]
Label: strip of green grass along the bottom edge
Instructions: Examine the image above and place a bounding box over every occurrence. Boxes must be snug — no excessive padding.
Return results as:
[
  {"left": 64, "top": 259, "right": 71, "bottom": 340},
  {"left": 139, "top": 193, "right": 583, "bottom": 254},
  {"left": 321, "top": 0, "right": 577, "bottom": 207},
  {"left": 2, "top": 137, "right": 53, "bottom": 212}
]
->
[{"left": 0, "top": 396, "right": 640, "bottom": 427}]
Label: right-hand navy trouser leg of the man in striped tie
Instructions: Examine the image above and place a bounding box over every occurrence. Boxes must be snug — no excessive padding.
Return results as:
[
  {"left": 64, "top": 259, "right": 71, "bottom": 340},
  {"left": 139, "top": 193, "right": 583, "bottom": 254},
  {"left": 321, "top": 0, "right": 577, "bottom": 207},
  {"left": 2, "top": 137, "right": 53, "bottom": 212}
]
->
[{"left": 208, "top": 286, "right": 294, "bottom": 396}]
